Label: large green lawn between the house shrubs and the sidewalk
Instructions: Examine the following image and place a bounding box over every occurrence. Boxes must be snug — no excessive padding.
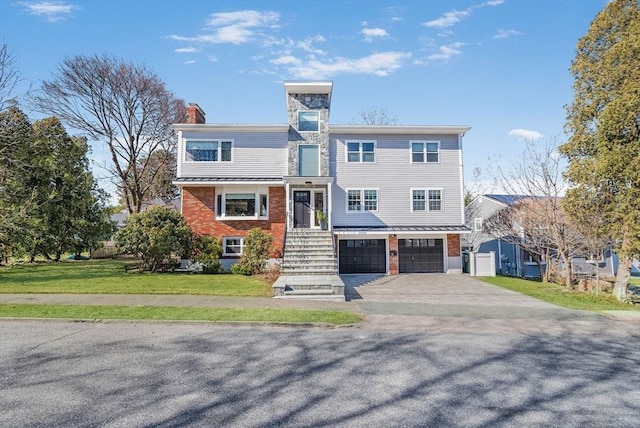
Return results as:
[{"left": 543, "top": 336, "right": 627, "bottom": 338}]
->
[{"left": 0, "top": 260, "right": 272, "bottom": 297}]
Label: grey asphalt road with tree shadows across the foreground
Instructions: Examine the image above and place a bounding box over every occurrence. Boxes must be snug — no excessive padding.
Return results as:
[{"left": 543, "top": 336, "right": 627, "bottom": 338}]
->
[{"left": 0, "top": 321, "right": 640, "bottom": 427}]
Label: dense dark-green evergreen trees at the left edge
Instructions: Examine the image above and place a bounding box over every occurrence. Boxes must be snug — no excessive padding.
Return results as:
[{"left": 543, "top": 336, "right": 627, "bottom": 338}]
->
[{"left": 0, "top": 107, "right": 112, "bottom": 261}]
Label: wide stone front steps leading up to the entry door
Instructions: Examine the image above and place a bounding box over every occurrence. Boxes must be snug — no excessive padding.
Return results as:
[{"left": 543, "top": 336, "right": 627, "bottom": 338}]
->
[{"left": 273, "top": 228, "right": 345, "bottom": 301}]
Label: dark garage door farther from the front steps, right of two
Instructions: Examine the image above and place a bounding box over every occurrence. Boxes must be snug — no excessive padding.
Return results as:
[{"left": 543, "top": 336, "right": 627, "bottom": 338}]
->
[{"left": 398, "top": 239, "right": 444, "bottom": 273}]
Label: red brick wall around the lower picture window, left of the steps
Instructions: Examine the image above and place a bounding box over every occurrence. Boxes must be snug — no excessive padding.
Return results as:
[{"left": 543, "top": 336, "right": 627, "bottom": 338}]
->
[{"left": 182, "top": 187, "right": 286, "bottom": 257}]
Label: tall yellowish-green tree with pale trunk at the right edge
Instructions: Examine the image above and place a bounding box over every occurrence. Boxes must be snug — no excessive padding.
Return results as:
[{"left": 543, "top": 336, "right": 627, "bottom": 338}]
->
[{"left": 560, "top": 0, "right": 640, "bottom": 300}]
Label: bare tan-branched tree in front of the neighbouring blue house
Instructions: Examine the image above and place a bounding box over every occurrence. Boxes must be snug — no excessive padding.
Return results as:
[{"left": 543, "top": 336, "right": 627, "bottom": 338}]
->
[{"left": 485, "top": 140, "right": 585, "bottom": 287}]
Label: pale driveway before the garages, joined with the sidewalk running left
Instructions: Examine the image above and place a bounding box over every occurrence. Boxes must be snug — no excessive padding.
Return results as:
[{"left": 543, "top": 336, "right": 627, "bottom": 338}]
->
[{"left": 0, "top": 274, "right": 640, "bottom": 334}]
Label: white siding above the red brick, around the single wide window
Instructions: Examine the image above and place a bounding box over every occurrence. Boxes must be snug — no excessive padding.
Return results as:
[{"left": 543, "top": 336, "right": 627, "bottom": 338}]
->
[{"left": 178, "top": 132, "right": 288, "bottom": 178}]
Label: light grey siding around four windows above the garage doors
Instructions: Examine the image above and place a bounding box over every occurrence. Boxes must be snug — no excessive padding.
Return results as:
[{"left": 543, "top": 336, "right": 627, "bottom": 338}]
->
[{"left": 329, "top": 134, "right": 463, "bottom": 226}]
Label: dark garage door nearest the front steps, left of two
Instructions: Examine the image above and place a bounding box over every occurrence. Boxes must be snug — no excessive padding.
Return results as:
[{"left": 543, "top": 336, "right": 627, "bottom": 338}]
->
[{"left": 339, "top": 239, "right": 387, "bottom": 273}]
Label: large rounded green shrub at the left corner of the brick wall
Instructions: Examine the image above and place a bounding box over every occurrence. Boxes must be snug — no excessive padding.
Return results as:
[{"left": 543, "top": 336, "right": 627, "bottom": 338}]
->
[{"left": 114, "top": 207, "right": 193, "bottom": 272}]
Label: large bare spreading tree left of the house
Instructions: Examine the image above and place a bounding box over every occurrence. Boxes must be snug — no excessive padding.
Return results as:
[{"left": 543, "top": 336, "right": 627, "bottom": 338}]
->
[{"left": 32, "top": 55, "right": 186, "bottom": 213}]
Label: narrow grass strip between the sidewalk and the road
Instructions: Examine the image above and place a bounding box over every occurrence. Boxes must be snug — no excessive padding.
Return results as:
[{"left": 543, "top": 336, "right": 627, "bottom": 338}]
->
[{"left": 0, "top": 304, "right": 362, "bottom": 325}]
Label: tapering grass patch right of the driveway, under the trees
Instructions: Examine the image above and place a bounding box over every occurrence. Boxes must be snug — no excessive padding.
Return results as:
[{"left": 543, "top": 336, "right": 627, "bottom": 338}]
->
[{"left": 480, "top": 276, "right": 640, "bottom": 311}]
